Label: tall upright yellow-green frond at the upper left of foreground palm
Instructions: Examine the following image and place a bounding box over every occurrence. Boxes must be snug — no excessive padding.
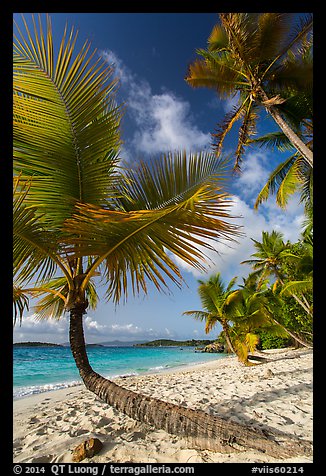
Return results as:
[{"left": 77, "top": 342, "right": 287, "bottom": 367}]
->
[{"left": 13, "top": 17, "right": 121, "bottom": 229}]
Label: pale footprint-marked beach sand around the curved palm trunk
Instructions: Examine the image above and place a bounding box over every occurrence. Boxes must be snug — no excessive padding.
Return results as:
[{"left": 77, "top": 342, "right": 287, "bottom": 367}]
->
[{"left": 13, "top": 349, "right": 313, "bottom": 464}]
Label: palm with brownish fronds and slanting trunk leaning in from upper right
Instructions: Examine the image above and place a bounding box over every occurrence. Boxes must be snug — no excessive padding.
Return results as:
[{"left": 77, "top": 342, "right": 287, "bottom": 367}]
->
[{"left": 185, "top": 13, "right": 313, "bottom": 168}]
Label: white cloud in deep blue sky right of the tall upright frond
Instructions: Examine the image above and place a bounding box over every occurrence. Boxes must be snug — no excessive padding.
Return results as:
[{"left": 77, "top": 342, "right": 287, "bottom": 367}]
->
[{"left": 101, "top": 51, "right": 211, "bottom": 155}]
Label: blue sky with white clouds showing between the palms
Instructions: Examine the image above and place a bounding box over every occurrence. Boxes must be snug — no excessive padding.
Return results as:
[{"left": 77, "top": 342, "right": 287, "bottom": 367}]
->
[{"left": 14, "top": 13, "right": 303, "bottom": 343}]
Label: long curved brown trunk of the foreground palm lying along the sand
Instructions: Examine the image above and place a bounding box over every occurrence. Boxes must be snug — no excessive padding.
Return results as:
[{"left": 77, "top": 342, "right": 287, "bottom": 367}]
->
[{"left": 70, "top": 304, "right": 311, "bottom": 458}]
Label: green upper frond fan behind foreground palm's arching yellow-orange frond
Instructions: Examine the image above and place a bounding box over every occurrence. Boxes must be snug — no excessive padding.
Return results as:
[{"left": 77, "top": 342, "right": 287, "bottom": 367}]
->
[{"left": 118, "top": 151, "right": 230, "bottom": 211}]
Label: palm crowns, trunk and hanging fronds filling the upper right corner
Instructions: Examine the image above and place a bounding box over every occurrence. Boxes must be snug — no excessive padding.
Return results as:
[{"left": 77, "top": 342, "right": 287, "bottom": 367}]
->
[{"left": 185, "top": 13, "right": 313, "bottom": 218}]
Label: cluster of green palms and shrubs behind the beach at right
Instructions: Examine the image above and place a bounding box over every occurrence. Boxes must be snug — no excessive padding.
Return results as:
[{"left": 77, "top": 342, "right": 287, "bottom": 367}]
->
[{"left": 184, "top": 231, "right": 313, "bottom": 358}]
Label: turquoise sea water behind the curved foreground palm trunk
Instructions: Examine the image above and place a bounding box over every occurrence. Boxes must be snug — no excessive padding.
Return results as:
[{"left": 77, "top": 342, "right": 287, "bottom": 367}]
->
[{"left": 13, "top": 346, "right": 225, "bottom": 399}]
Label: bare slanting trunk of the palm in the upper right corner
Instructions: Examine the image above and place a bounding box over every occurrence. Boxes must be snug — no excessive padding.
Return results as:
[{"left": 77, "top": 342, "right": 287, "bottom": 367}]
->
[{"left": 259, "top": 88, "right": 313, "bottom": 168}]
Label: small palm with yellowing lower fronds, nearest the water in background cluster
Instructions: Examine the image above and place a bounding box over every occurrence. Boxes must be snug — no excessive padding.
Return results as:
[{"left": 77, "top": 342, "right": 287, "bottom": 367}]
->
[{"left": 183, "top": 273, "right": 237, "bottom": 353}]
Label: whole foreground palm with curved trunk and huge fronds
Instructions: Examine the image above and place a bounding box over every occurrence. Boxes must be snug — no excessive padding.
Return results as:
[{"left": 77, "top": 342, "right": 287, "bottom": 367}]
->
[{"left": 13, "top": 11, "right": 310, "bottom": 457}]
